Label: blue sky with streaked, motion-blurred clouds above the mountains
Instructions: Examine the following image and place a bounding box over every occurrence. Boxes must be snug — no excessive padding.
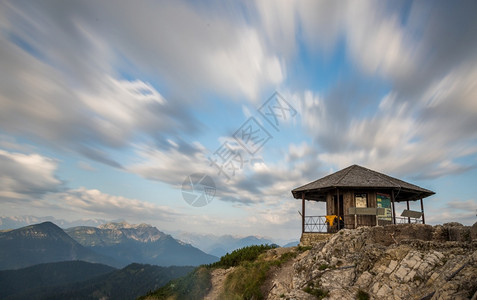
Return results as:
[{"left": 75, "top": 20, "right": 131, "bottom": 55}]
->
[{"left": 0, "top": 0, "right": 477, "bottom": 240}]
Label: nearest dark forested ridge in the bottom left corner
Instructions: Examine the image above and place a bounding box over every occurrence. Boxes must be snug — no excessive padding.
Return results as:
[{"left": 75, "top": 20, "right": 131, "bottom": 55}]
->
[{"left": 0, "top": 261, "right": 194, "bottom": 300}]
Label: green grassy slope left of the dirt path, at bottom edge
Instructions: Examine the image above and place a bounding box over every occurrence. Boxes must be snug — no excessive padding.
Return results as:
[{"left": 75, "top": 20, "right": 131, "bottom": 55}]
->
[{"left": 138, "top": 266, "right": 212, "bottom": 300}]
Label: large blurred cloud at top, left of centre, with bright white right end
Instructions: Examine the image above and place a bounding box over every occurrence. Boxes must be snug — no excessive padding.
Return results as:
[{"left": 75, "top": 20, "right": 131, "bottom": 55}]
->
[{"left": 79, "top": 1, "right": 284, "bottom": 100}]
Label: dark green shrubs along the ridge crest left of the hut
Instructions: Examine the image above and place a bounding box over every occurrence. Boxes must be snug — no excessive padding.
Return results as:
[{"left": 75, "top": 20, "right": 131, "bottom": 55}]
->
[{"left": 209, "top": 245, "right": 277, "bottom": 268}]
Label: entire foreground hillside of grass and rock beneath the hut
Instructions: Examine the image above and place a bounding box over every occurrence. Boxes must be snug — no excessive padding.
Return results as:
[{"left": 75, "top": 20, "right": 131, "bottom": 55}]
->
[{"left": 141, "top": 223, "right": 477, "bottom": 300}]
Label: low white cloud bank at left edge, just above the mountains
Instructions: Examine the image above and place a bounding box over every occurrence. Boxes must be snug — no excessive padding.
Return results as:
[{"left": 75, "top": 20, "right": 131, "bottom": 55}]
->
[{"left": 0, "top": 145, "right": 177, "bottom": 225}]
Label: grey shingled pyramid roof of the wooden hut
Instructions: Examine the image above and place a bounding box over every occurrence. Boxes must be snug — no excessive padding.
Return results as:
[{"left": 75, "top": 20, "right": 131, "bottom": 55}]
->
[{"left": 292, "top": 165, "right": 435, "bottom": 202}]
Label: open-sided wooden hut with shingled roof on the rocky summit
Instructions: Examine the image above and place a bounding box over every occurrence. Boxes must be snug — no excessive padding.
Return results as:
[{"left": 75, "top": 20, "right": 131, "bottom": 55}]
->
[{"left": 292, "top": 165, "right": 434, "bottom": 233}]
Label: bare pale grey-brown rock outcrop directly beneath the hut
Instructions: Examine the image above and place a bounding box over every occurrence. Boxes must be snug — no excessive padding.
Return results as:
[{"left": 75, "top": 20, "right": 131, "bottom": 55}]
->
[{"left": 267, "top": 223, "right": 477, "bottom": 299}]
